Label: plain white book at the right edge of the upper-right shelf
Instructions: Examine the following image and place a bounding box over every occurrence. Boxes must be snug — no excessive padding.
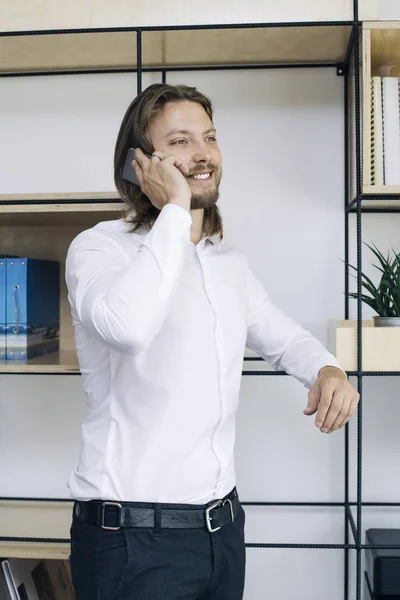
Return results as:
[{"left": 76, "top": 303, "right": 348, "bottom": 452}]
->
[{"left": 382, "top": 77, "right": 400, "bottom": 185}]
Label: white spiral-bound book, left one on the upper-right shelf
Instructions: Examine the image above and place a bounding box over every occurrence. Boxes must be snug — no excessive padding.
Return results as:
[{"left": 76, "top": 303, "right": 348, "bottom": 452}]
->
[{"left": 371, "top": 77, "right": 384, "bottom": 185}]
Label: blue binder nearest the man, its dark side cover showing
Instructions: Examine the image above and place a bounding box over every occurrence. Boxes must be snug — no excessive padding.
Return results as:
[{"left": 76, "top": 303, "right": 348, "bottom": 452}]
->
[{"left": 5, "top": 258, "right": 60, "bottom": 361}]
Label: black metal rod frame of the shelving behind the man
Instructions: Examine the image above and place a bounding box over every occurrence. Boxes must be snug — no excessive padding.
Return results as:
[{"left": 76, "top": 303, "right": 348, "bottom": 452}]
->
[{"left": 0, "top": 0, "right": 400, "bottom": 600}]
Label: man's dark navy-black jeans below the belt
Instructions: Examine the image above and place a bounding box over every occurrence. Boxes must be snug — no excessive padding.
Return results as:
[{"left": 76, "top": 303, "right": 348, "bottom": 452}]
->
[{"left": 70, "top": 494, "right": 245, "bottom": 600}]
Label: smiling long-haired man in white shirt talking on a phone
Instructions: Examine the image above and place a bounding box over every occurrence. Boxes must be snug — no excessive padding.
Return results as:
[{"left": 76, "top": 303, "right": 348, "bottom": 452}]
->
[{"left": 66, "top": 84, "right": 358, "bottom": 600}]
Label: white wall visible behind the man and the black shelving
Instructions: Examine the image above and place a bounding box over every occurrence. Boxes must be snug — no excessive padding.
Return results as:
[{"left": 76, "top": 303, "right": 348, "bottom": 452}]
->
[{"left": 0, "top": 69, "right": 400, "bottom": 600}]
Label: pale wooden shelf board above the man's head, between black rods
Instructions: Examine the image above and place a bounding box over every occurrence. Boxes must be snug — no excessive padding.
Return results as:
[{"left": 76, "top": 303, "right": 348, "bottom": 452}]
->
[{"left": 0, "top": 25, "right": 351, "bottom": 73}]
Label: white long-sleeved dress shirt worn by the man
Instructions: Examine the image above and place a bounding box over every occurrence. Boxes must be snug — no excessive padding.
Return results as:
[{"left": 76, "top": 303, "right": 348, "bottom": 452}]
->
[{"left": 66, "top": 205, "right": 340, "bottom": 504}]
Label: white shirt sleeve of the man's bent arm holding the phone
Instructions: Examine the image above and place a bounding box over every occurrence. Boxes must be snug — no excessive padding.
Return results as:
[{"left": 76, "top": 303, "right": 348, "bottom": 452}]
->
[{"left": 65, "top": 205, "right": 192, "bottom": 355}]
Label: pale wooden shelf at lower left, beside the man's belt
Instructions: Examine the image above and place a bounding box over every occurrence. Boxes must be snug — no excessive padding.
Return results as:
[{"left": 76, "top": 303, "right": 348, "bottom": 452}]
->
[{"left": 0, "top": 500, "right": 73, "bottom": 560}]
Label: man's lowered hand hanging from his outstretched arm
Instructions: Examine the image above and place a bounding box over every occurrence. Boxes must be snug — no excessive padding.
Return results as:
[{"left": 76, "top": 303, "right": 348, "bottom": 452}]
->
[{"left": 304, "top": 367, "right": 360, "bottom": 433}]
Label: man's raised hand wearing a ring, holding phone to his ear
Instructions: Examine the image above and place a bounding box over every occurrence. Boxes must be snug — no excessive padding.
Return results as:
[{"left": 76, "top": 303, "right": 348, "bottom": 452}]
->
[{"left": 132, "top": 148, "right": 192, "bottom": 211}]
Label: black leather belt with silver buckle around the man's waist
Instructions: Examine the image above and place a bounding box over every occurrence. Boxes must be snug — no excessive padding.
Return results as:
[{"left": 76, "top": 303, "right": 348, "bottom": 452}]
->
[{"left": 74, "top": 489, "right": 240, "bottom": 533}]
